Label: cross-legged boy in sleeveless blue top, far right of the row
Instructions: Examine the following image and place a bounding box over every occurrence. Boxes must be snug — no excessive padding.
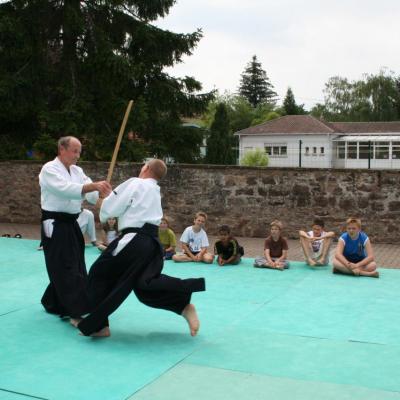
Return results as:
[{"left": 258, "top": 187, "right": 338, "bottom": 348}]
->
[{"left": 332, "top": 218, "right": 379, "bottom": 278}]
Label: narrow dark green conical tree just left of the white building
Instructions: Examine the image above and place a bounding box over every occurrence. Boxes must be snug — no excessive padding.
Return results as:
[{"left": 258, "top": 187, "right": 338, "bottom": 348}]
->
[{"left": 206, "top": 103, "right": 235, "bottom": 164}]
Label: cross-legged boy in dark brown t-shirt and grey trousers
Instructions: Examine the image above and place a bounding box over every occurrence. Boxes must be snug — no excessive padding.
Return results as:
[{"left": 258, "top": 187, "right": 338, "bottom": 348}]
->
[{"left": 254, "top": 220, "right": 289, "bottom": 271}]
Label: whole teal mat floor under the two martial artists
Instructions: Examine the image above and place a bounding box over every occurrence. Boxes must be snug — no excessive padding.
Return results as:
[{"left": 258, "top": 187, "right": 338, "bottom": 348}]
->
[{"left": 0, "top": 238, "right": 400, "bottom": 400}]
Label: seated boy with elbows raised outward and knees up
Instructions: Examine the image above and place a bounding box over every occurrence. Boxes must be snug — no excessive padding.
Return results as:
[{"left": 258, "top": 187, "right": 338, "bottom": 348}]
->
[{"left": 299, "top": 218, "right": 335, "bottom": 267}]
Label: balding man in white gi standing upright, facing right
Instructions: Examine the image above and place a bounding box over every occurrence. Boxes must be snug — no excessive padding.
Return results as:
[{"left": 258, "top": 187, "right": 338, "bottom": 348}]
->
[{"left": 39, "top": 136, "right": 111, "bottom": 325}]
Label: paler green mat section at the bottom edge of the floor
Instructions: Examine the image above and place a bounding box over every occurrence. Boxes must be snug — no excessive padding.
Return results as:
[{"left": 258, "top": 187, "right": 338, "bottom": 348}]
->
[{"left": 129, "top": 363, "right": 400, "bottom": 400}]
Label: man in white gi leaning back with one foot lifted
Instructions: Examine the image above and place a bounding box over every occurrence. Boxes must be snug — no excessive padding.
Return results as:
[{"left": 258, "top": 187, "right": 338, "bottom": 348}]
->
[{"left": 78, "top": 159, "right": 205, "bottom": 337}]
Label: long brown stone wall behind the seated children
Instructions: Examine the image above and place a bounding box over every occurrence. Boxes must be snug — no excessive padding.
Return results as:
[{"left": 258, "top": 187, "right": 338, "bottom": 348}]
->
[{"left": 0, "top": 161, "right": 400, "bottom": 243}]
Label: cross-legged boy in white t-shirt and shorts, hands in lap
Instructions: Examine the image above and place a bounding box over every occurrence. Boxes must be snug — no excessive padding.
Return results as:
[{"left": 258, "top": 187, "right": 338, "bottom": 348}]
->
[{"left": 172, "top": 211, "right": 214, "bottom": 264}]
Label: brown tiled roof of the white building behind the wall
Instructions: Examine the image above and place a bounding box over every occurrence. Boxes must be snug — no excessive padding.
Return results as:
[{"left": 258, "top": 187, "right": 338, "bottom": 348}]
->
[{"left": 235, "top": 115, "right": 400, "bottom": 136}]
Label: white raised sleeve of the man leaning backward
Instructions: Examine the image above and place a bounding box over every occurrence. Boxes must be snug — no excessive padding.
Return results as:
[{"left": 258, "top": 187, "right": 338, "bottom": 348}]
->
[{"left": 99, "top": 178, "right": 138, "bottom": 223}]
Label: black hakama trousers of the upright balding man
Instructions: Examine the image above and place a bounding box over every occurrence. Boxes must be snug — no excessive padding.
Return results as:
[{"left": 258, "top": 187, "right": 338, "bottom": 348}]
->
[{"left": 41, "top": 220, "right": 90, "bottom": 318}]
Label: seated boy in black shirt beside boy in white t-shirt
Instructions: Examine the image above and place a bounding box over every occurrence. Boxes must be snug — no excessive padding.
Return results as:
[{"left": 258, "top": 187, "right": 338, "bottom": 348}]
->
[{"left": 214, "top": 225, "right": 244, "bottom": 267}]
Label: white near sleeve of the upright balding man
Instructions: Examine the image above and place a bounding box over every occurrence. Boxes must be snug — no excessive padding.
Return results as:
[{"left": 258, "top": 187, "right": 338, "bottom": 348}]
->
[{"left": 39, "top": 166, "right": 83, "bottom": 200}]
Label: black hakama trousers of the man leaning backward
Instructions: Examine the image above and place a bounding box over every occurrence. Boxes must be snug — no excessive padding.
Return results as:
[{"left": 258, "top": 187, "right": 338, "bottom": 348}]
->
[{"left": 78, "top": 233, "right": 205, "bottom": 335}]
